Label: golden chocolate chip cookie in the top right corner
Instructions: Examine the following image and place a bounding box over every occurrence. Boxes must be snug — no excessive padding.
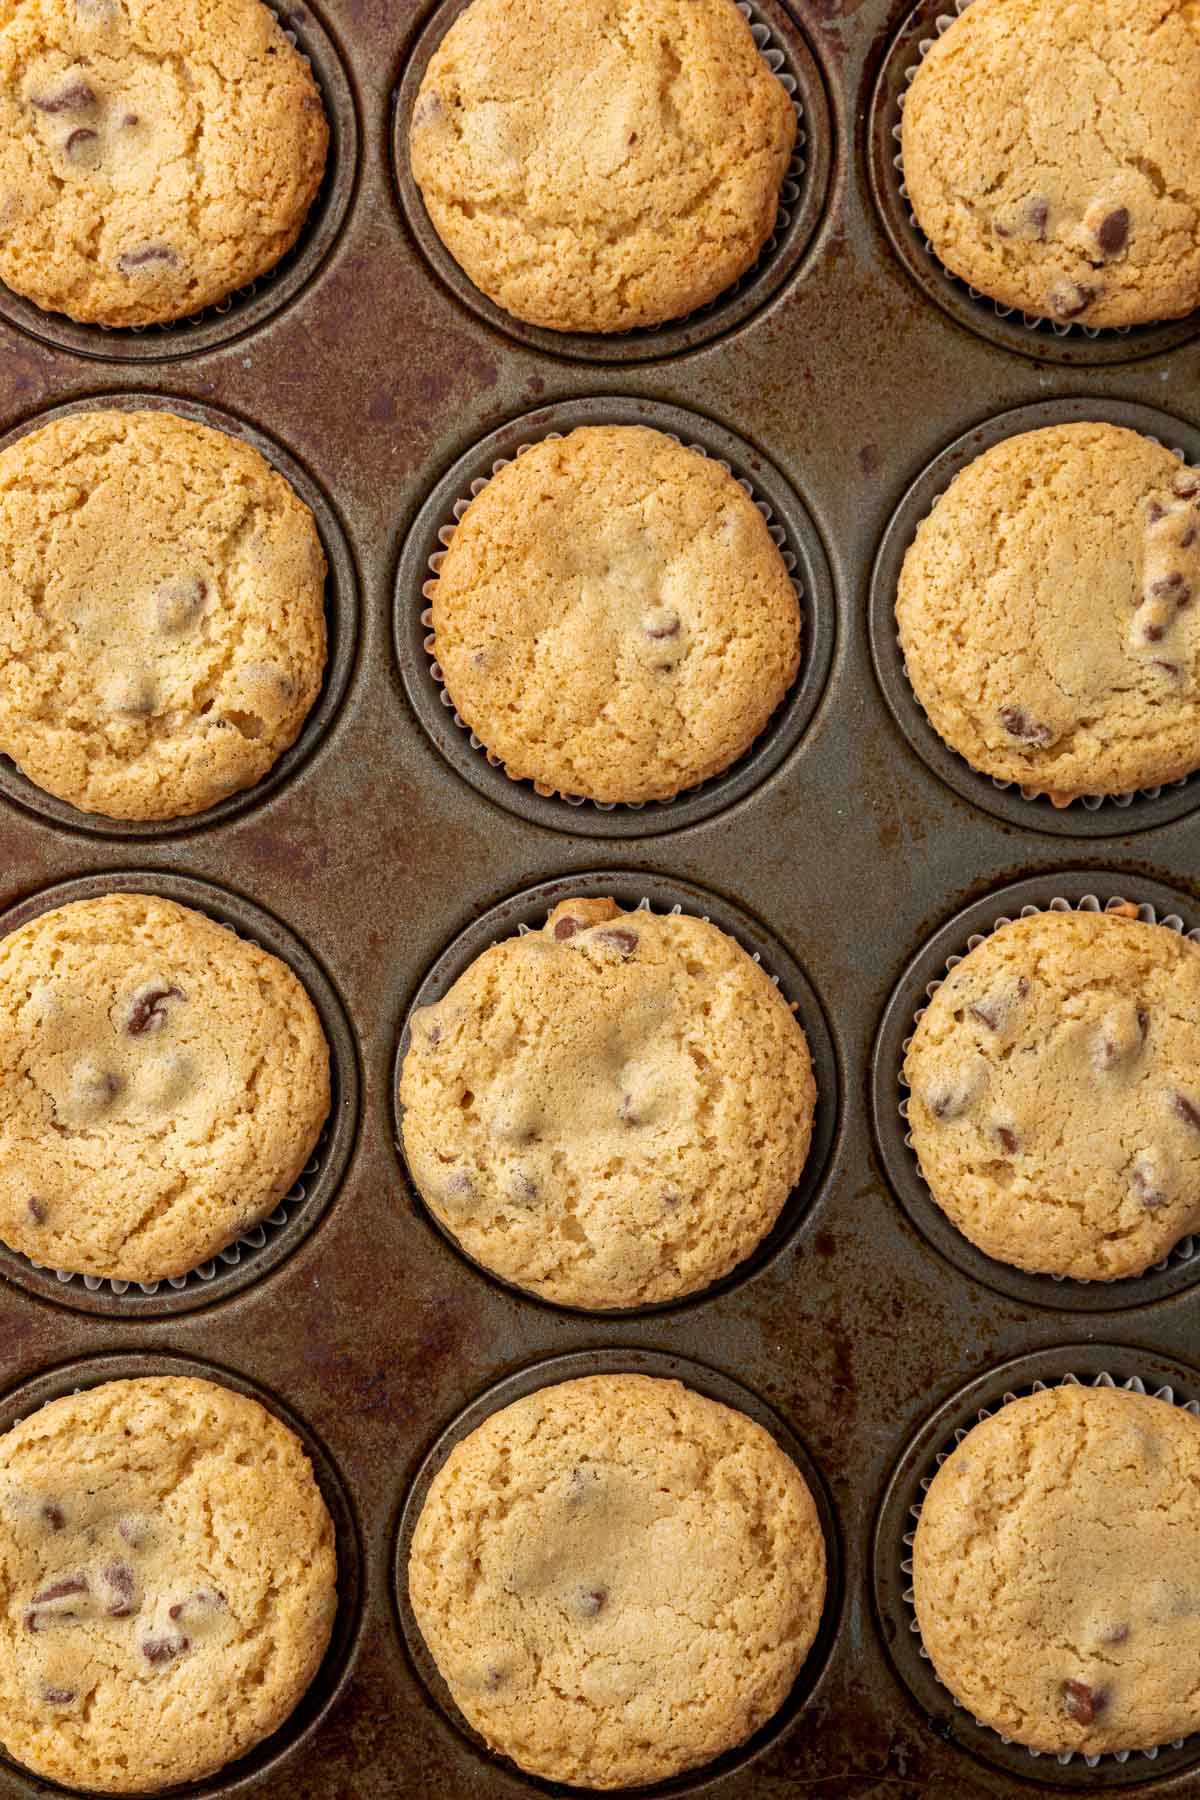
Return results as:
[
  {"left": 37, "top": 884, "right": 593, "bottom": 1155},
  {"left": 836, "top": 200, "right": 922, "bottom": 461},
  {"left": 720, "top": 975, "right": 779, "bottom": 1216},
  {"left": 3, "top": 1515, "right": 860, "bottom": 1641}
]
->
[{"left": 901, "top": 0, "right": 1200, "bottom": 326}]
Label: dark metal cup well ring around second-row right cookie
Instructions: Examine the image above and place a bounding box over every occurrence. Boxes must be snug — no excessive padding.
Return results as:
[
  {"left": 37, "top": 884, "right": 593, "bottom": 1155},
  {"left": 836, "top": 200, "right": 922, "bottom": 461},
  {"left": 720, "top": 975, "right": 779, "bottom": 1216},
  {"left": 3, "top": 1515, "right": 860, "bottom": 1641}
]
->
[{"left": 869, "top": 398, "right": 1200, "bottom": 837}]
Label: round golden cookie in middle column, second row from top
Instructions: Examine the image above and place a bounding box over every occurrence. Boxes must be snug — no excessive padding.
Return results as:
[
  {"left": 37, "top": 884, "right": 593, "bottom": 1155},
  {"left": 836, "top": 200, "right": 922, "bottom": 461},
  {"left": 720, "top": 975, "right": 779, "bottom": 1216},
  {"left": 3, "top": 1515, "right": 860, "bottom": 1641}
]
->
[{"left": 432, "top": 425, "right": 801, "bottom": 803}]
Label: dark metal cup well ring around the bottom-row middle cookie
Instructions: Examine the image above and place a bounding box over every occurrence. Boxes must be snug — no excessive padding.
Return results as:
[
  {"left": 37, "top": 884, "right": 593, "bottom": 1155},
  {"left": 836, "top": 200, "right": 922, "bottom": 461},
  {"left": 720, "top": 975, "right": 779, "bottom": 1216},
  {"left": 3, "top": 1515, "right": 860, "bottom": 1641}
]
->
[{"left": 392, "top": 1348, "right": 842, "bottom": 1800}]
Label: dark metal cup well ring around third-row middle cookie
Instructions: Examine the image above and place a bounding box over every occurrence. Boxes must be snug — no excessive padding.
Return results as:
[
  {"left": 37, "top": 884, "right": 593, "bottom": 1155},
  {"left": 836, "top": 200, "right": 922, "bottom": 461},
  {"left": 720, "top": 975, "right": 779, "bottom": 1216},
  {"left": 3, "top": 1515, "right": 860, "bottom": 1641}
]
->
[{"left": 392, "top": 869, "right": 840, "bottom": 1319}]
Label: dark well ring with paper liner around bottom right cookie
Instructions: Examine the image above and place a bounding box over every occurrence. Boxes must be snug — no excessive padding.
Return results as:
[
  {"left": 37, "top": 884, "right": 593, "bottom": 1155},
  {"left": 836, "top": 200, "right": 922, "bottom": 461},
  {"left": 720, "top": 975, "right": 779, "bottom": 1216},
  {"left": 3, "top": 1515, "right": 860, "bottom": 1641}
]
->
[{"left": 873, "top": 1343, "right": 1200, "bottom": 1793}]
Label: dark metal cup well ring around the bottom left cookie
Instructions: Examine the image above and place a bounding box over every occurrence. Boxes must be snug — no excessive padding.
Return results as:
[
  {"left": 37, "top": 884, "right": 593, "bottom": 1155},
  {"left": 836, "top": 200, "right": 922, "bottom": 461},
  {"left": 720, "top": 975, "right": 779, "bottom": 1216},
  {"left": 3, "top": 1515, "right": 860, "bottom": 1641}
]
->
[{"left": 0, "top": 1352, "right": 365, "bottom": 1800}]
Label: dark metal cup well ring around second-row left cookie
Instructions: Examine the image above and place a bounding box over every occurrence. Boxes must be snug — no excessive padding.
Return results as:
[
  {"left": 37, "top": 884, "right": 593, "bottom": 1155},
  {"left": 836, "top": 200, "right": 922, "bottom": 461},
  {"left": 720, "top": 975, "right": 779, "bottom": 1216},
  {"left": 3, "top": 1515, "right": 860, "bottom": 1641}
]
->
[{"left": 0, "top": 389, "right": 360, "bottom": 841}]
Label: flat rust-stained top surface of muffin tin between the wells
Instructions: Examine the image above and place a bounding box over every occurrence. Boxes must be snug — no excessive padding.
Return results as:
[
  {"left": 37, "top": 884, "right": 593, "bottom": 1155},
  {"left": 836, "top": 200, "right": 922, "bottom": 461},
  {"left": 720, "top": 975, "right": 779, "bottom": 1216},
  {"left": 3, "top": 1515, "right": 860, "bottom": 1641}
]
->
[{"left": 0, "top": 0, "right": 1200, "bottom": 1800}]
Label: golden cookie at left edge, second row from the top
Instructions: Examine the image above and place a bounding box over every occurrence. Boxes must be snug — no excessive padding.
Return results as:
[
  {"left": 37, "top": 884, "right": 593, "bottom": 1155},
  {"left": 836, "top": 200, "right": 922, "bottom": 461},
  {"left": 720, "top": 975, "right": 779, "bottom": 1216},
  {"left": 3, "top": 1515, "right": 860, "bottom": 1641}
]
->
[{"left": 0, "top": 410, "right": 326, "bottom": 819}]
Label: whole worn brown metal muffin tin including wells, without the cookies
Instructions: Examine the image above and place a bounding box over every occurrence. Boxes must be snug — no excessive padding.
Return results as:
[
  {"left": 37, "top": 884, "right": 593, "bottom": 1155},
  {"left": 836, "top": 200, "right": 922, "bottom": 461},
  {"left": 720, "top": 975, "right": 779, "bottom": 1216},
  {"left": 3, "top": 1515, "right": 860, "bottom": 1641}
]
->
[{"left": 0, "top": 0, "right": 1200, "bottom": 1800}]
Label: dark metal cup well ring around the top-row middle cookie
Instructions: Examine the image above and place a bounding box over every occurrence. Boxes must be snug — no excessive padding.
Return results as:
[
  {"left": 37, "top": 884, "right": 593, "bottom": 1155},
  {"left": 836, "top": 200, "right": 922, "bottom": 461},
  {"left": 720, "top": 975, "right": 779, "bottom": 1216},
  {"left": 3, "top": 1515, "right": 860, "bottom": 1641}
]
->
[{"left": 390, "top": 0, "right": 833, "bottom": 364}]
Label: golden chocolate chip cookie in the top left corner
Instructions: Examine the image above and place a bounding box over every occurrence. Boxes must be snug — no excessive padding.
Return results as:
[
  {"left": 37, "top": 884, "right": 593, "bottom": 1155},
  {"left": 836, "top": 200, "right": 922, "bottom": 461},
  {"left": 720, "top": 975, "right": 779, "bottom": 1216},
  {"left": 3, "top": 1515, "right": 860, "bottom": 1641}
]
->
[{"left": 0, "top": 0, "right": 329, "bottom": 326}]
